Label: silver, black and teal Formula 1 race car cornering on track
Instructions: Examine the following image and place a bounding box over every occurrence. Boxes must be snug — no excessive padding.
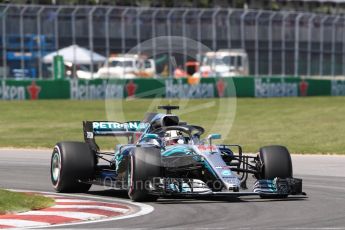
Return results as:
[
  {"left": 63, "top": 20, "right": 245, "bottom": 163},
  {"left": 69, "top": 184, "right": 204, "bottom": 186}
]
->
[{"left": 50, "top": 106, "right": 305, "bottom": 201}]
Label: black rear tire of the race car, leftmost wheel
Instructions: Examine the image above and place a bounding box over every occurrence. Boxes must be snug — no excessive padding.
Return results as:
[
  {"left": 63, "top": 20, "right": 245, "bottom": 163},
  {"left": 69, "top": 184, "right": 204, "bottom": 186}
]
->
[{"left": 50, "top": 142, "right": 95, "bottom": 192}]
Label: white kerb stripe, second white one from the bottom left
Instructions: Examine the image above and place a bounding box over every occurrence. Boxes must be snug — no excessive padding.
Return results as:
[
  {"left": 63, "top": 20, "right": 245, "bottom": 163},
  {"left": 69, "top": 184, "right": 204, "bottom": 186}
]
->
[{"left": 18, "top": 211, "right": 107, "bottom": 220}]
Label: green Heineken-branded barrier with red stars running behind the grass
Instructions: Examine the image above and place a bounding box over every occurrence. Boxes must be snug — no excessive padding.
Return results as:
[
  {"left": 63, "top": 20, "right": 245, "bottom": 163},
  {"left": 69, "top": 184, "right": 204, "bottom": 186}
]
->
[{"left": 0, "top": 77, "right": 345, "bottom": 100}]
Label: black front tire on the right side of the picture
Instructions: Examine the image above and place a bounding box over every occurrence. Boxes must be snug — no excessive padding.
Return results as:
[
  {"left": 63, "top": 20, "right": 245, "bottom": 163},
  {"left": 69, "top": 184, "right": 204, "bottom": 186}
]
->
[{"left": 259, "top": 145, "right": 292, "bottom": 198}]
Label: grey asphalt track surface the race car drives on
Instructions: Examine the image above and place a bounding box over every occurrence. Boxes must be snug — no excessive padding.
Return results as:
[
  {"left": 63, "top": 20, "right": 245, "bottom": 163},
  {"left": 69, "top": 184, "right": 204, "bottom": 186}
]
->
[{"left": 0, "top": 149, "right": 345, "bottom": 229}]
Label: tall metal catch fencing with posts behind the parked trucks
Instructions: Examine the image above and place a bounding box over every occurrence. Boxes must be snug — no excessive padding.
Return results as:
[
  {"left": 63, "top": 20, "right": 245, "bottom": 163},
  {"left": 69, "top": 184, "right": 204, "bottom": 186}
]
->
[{"left": 0, "top": 4, "right": 345, "bottom": 78}]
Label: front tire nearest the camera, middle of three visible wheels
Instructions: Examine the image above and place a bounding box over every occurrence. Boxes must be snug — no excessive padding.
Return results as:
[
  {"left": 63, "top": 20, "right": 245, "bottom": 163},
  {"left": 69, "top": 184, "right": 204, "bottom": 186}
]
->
[{"left": 128, "top": 147, "right": 161, "bottom": 202}]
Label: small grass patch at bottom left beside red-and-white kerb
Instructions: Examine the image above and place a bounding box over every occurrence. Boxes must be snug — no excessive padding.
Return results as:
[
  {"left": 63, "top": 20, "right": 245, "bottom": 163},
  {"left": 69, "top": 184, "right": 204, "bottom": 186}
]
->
[{"left": 0, "top": 189, "right": 54, "bottom": 215}]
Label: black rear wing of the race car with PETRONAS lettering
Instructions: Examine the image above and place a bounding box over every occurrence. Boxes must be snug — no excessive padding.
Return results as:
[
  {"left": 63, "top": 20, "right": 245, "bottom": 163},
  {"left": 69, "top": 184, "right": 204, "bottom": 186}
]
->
[{"left": 83, "top": 121, "right": 149, "bottom": 151}]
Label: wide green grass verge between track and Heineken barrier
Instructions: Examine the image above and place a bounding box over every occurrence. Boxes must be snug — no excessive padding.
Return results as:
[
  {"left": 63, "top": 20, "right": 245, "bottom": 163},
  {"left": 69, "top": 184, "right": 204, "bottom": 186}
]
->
[{"left": 0, "top": 97, "right": 345, "bottom": 154}]
